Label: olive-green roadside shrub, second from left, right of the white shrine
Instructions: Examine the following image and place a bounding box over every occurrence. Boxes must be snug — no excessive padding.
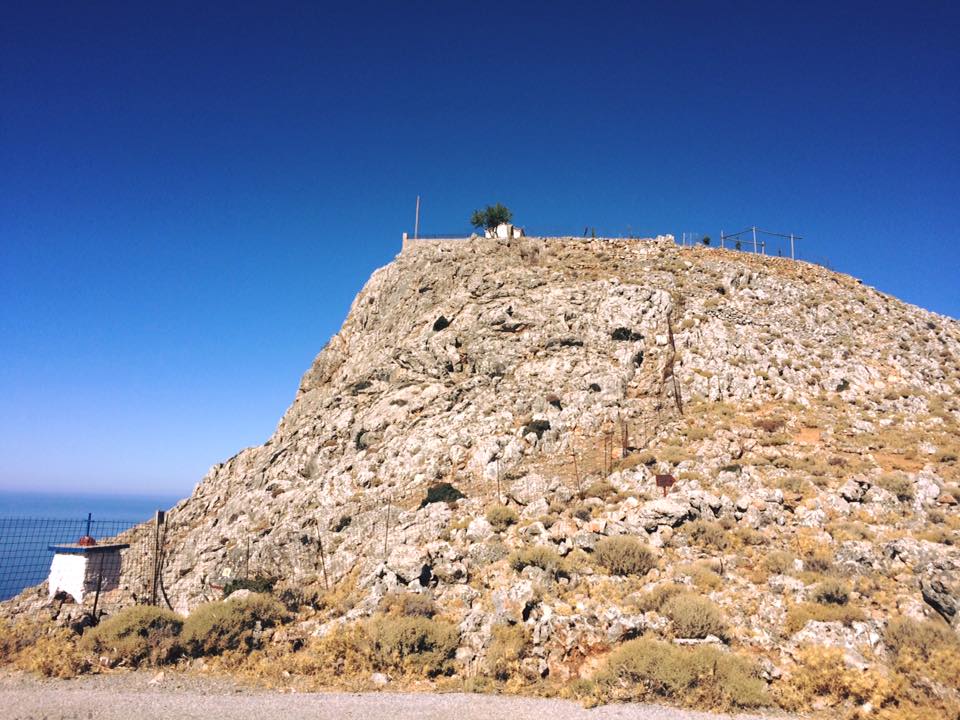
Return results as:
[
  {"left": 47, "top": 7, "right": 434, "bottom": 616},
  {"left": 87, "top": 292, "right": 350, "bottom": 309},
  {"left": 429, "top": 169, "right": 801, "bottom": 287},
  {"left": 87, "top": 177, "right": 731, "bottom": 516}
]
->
[{"left": 181, "top": 595, "right": 286, "bottom": 657}]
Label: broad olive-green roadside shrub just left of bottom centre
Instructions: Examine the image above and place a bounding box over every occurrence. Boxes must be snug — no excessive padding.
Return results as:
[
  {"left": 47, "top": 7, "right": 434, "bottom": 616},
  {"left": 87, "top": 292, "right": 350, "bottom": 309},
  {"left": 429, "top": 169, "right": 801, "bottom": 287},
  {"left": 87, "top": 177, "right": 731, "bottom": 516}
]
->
[{"left": 370, "top": 617, "right": 460, "bottom": 677}]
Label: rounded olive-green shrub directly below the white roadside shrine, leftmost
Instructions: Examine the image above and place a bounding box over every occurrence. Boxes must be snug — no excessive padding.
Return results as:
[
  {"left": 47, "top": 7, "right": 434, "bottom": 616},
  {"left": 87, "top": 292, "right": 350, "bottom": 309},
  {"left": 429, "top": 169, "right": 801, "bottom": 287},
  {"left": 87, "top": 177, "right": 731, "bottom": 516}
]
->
[{"left": 80, "top": 605, "right": 183, "bottom": 667}]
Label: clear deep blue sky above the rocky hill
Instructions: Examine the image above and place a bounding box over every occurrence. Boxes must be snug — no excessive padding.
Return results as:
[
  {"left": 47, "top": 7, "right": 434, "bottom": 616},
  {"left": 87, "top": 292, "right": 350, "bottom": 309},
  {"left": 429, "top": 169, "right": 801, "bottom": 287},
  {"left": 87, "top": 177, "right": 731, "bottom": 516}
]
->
[{"left": 0, "top": 2, "right": 960, "bottom": 493}]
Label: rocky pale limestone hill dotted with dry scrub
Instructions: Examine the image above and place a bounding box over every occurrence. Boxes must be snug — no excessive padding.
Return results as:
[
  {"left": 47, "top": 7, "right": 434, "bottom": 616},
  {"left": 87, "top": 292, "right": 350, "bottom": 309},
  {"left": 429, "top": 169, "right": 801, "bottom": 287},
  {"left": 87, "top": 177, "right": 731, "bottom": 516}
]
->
[{"left": 7, "top": 237, "right": 960, "bottom": 704}]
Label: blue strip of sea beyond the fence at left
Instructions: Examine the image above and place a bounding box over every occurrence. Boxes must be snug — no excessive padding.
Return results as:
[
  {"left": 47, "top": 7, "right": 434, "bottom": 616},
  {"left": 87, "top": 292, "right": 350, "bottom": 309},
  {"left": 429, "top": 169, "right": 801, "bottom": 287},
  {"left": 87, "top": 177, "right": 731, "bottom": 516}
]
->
[{"left": 0, "top": 490, "right": 181, "bottom": 600}]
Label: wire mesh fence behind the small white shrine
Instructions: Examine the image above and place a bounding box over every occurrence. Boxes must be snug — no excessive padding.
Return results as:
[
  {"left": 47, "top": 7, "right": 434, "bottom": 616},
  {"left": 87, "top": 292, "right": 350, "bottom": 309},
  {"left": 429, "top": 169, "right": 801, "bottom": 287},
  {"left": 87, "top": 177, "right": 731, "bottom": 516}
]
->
[{"left": 0, "top": 517, "right": 150, "bottom": 600}]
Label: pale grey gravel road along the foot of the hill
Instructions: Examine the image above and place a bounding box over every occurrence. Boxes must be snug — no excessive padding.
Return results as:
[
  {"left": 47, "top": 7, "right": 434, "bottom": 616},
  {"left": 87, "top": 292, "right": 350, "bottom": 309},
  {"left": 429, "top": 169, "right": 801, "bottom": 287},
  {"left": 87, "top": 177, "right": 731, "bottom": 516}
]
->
[{"left": 0, "top": 673, "right": 796, "bottom": 720}]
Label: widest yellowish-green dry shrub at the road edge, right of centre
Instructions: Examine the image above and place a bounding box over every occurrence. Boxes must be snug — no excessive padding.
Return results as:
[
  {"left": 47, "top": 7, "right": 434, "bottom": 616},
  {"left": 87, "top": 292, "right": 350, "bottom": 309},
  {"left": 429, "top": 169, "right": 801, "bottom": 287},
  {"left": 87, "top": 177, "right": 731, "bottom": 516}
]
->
[{"left": 596, "top": 638, "right": 769, "bottom": 709}]
